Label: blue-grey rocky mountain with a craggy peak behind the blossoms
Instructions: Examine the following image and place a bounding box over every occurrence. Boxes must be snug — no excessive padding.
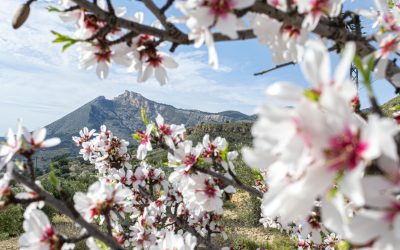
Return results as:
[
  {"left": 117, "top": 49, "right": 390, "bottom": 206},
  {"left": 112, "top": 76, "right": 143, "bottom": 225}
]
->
[{"left": 32, "top": 91, "right": 255, "bottom": 165}]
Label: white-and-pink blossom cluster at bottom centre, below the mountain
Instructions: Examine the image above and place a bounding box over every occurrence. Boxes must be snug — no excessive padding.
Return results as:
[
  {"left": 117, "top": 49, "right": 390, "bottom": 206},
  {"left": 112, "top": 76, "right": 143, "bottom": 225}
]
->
[{"left": 69, "top": 115, "right": 245, "bottom": 249}]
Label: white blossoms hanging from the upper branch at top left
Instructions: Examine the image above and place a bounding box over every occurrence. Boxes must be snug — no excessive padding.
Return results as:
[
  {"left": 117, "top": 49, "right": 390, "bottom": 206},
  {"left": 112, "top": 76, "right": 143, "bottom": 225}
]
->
[{"left": 60, "top": 0, "right": 178, "bottom": 85}]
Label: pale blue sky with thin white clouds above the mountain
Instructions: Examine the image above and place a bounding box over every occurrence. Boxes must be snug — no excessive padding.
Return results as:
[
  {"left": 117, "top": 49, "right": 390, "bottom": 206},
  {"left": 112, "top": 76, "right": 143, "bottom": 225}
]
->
[{"left": 0, "top": 0, "right": 394, "bottom": 134}]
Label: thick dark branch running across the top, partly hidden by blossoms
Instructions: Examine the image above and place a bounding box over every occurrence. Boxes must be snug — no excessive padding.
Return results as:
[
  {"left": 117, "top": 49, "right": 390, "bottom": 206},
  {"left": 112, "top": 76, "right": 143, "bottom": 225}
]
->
[{"left": 72, "top": 0, "right": 400, "bottom": 89}]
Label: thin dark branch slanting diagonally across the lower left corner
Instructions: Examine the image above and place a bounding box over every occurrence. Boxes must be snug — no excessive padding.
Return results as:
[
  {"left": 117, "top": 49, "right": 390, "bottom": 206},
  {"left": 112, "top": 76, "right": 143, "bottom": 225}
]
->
[{"left": 12, "top": 169, "right": 122, "bottom": 250}]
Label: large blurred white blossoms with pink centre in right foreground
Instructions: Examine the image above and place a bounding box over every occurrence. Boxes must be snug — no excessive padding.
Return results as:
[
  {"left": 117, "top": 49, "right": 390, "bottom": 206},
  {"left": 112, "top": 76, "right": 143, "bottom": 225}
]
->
[{"left": 243, "top": 40, "right": 400, "bottom": 249}]
